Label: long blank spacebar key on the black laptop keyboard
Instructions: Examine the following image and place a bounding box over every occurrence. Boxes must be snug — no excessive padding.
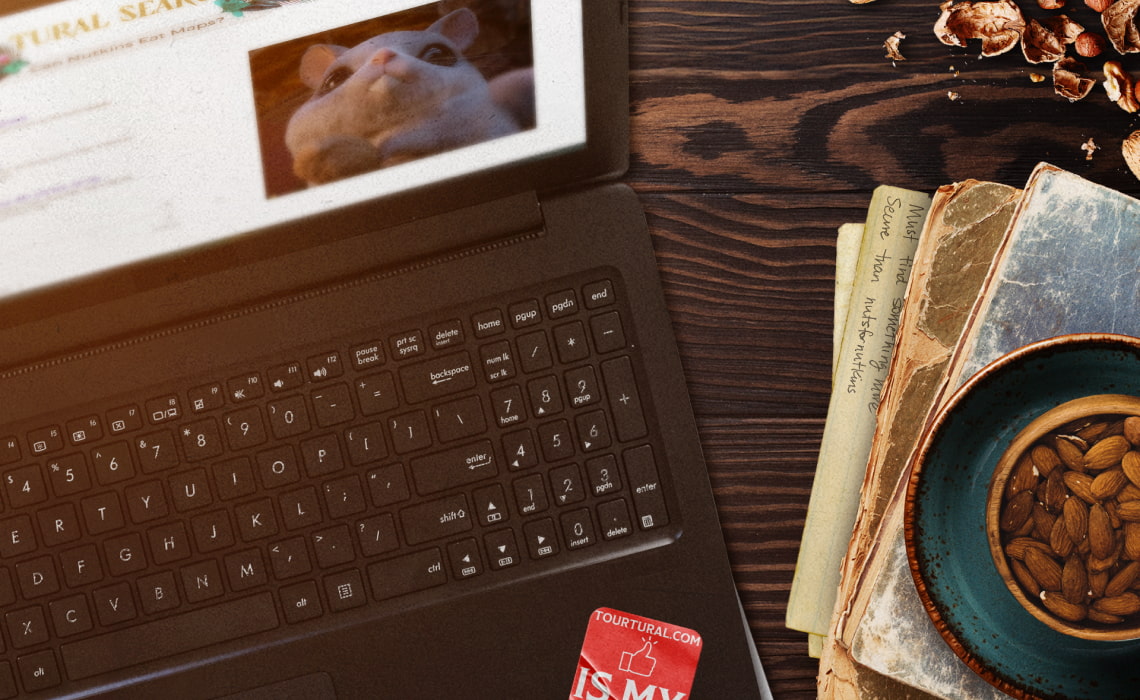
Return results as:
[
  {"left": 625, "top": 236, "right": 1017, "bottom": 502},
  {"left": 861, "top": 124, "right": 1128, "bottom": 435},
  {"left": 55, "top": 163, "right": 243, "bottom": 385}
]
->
[{"left": 59, "top": 593, "right": 277, "bottom": 681}]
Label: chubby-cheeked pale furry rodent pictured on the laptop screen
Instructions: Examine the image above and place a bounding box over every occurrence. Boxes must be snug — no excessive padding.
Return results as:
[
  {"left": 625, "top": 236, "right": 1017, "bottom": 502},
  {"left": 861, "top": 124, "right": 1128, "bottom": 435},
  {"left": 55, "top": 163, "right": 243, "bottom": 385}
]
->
[{"left": 285, "top": 8, "right": 534, "bottom": 185}]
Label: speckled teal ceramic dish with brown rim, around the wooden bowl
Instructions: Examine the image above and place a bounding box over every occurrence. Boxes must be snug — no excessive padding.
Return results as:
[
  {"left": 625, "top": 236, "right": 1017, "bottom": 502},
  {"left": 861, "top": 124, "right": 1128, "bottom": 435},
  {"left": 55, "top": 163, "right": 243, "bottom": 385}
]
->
[{"left": 905, "top": 334, "right": 1140, "bottom": 700}]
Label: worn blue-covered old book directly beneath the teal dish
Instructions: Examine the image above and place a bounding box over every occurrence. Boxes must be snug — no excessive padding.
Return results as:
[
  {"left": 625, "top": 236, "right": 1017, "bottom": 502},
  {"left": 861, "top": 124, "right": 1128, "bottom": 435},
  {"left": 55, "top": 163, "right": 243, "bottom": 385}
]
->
[{"left": 825, "top": 164, "right": 1140, "bottom": 698}]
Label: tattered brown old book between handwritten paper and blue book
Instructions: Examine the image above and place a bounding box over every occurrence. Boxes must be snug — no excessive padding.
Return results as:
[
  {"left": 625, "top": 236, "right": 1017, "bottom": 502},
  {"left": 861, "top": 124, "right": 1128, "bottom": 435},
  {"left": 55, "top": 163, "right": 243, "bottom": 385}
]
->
[{"left": 820, "top": 180, "right": 1019, "bottom": 698}]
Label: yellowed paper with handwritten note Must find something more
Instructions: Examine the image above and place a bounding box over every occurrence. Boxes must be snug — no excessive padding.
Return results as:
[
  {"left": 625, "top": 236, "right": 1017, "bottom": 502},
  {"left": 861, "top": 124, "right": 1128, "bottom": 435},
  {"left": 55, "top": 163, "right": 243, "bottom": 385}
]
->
[{"left": 787, "top": 186, "right": 930, "bottom": 636}]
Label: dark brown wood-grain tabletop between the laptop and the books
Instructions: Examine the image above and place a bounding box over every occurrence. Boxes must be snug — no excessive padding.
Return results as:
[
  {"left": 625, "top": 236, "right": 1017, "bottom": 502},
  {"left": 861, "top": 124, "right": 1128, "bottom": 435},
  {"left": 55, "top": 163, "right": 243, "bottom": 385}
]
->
[{"left": 627, "top": 0, "right": 1140, "bottom": 700}]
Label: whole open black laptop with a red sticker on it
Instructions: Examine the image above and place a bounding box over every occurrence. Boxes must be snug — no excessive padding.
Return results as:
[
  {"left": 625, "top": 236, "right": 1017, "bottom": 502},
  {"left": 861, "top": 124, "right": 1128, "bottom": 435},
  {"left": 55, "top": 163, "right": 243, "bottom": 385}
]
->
[{"left": 0, "top": 0, "right": 770, "bottom": 700}]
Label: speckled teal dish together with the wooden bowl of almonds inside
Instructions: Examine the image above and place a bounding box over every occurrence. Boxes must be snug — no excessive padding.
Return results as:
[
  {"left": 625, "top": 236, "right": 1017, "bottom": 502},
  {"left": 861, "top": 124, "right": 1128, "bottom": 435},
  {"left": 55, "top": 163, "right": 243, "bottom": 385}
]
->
[{"left": 907, "top": 333, "right": 1140, "bottom": 700}]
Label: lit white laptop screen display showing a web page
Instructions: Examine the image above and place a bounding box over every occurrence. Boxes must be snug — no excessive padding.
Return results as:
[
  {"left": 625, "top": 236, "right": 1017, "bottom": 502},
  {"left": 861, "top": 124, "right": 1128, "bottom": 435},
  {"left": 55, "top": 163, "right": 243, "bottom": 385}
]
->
[{"left": 0, "top": 0, "right": 586, "bottom": 298}]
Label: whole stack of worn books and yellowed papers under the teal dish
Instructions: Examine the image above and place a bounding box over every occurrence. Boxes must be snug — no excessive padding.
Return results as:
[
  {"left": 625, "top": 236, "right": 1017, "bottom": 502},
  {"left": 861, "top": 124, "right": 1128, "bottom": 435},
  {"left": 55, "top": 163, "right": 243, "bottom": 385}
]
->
[{"left": 787, "top": 164, "right": 1140, "bottom": 699}]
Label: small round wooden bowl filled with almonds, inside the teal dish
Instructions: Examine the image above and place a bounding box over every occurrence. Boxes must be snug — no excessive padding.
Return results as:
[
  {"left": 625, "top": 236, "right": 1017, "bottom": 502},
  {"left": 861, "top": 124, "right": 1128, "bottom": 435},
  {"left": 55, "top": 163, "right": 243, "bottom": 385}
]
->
[{"left": 986, "top": 393, "right": 1140, "bottom": 641}]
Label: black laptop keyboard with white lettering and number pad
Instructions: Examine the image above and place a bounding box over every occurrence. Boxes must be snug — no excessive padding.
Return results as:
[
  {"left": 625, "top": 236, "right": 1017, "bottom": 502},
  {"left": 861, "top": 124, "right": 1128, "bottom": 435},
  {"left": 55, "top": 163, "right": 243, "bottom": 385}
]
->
[{"left": 0, "top": 272, "right": 669, "bottom": 698}]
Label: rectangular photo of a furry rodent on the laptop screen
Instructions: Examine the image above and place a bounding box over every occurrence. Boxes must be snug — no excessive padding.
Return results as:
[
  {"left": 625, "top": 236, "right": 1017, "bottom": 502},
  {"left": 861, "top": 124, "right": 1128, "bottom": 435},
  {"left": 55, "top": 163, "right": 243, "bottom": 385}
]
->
[{"left": 251, "top": 0, "right": 535, "bottom": 196}]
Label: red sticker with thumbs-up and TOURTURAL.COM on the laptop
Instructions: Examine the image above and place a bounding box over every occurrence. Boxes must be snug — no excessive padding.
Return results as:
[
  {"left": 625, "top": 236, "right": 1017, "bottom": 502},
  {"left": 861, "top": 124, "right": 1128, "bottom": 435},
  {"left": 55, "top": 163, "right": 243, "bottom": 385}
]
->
[{"left": 570, "top": 608, "right": 701, "bottom": 700}]
